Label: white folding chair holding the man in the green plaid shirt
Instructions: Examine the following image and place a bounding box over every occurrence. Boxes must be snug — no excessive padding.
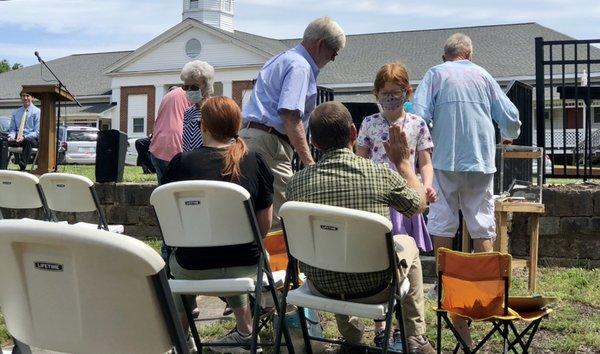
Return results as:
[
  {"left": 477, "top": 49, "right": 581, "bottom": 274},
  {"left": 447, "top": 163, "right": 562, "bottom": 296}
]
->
[{"left": 276, "top": 202, "right": 410, "bottom": 354}]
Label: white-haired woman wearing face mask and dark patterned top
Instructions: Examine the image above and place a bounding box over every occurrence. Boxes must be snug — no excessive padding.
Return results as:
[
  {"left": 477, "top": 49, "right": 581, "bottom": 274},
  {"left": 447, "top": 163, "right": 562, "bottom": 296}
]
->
[{"left": 180, "top": 60, "right": 215, "bottom": 152}]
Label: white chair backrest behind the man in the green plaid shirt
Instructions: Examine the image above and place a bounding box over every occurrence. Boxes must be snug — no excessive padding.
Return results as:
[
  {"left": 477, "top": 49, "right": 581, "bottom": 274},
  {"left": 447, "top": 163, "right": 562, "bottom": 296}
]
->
[{"left": 279, "top": 202, "right": 392, "bottom": 273}]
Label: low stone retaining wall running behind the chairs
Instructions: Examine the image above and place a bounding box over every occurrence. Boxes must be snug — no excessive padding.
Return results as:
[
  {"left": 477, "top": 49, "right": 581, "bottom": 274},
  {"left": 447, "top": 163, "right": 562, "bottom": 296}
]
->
[{"left": 3, "top": 183, "right": 600, "bottom": 267}]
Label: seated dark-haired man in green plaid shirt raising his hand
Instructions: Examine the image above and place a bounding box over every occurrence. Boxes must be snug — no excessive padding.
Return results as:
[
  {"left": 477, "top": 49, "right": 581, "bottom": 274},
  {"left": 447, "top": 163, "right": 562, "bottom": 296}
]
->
[{"left": 286, "top": 102, "right": 435, "bottom": 353}]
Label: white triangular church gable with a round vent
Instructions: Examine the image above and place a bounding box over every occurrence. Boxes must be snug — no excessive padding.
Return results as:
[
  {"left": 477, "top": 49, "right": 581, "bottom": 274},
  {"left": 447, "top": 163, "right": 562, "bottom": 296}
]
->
[{"left": 120, "top": 28, "right": 266, "bottom": 72}]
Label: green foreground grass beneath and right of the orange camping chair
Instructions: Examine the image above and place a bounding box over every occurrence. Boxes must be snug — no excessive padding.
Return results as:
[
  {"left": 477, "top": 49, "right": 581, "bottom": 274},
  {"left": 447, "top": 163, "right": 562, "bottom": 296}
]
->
[{"left": 0, "top": 266, "right": 600, "bottom": 353}]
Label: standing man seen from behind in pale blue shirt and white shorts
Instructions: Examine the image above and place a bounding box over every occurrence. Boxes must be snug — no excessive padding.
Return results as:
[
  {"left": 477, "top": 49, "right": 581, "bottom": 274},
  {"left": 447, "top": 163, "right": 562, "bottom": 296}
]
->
[{"left": 414, "top": 33, "right": 521, "bottom": 344}]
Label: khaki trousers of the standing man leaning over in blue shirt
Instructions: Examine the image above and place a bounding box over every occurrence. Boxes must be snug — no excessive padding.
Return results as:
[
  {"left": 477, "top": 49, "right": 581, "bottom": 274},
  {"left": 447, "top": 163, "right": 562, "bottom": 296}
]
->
[{"left": 240, "top": 128, "right": 294, "bottom": 231}]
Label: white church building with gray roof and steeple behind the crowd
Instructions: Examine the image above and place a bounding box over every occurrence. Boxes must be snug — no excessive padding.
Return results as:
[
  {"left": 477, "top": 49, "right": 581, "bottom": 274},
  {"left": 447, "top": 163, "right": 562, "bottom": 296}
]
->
[{"left": 0, "top": 0, "right": 600, "bottom": 144}]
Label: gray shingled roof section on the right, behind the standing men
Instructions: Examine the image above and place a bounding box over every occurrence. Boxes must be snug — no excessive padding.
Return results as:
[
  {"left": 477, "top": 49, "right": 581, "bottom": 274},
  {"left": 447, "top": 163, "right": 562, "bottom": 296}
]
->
[{"left": 312, "top": 23, "right": 584, "bottom": 85}]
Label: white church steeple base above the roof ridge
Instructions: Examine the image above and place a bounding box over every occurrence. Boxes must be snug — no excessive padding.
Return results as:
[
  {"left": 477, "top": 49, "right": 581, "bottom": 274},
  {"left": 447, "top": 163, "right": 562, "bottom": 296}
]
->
[{"left": 182, "top": 0, "right": 233, "bottom": 32}]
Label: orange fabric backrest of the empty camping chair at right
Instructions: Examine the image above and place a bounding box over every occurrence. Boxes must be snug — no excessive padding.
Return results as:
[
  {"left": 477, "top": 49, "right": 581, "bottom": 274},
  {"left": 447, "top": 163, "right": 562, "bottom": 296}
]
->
[{"left": 437, "top": 248, "right": 511, "bottom": 319}]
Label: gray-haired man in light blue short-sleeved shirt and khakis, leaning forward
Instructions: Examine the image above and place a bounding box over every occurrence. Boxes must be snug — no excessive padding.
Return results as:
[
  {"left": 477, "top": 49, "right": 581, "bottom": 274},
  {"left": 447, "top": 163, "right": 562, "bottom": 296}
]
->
[{"left": 240, "top": 17, "right": 346, "bottom": 230}]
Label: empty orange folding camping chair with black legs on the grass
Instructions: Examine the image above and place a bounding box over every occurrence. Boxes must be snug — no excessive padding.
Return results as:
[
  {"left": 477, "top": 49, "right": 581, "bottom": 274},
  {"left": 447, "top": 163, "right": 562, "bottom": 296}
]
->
[{"left": 436, "top": 248, "right": 553, "bottom": 353}]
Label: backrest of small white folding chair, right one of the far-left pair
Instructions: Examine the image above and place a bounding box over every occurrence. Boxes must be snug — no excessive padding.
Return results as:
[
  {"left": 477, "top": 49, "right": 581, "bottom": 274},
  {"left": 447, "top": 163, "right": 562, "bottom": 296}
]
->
[{"left": 40, "top": 173, "right": 98, "bottom": 212}]
